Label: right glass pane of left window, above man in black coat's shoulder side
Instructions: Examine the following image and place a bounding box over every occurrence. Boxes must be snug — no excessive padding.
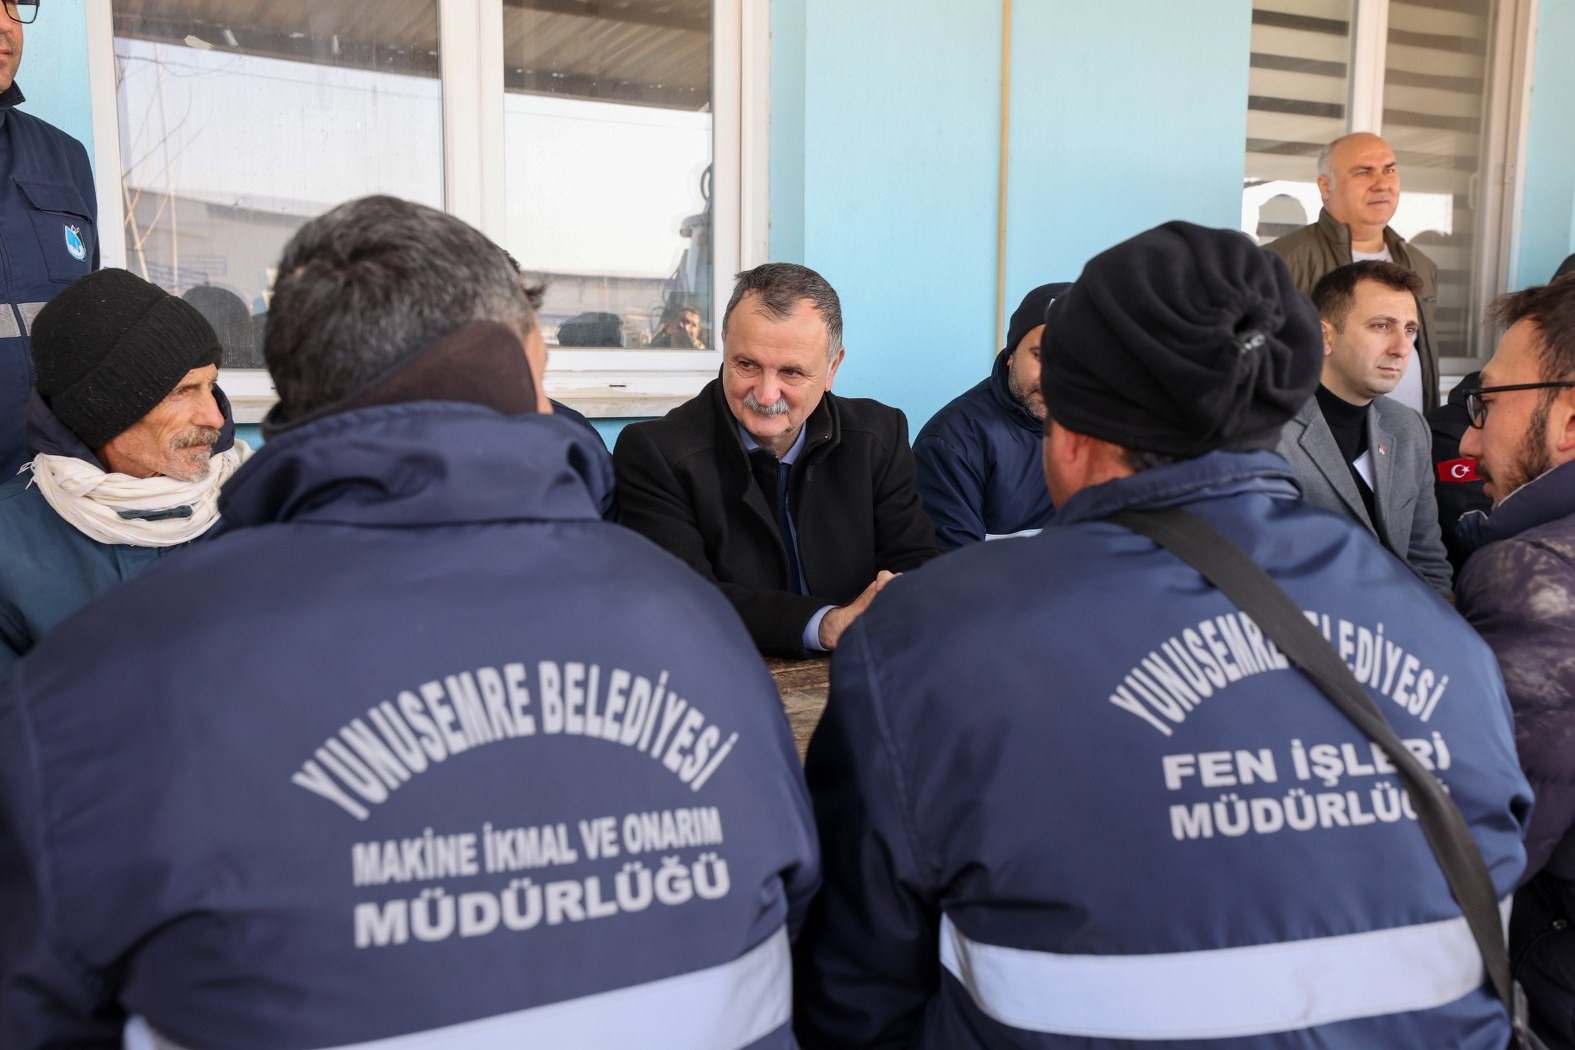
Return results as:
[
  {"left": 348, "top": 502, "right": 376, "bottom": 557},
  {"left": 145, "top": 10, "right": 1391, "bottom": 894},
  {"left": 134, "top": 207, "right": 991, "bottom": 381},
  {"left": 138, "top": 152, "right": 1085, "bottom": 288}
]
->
[{"left": 504, "top": 0, "right": 713, "bottom": 348}]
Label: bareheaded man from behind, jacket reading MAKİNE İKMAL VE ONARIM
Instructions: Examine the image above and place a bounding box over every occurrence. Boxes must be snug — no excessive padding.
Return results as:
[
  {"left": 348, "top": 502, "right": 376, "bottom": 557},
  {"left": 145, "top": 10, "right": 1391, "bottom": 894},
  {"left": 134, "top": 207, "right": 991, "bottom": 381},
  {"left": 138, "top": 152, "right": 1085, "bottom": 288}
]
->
[{"left": 0, "top": 197, "right": 817, "bottom": 1050}]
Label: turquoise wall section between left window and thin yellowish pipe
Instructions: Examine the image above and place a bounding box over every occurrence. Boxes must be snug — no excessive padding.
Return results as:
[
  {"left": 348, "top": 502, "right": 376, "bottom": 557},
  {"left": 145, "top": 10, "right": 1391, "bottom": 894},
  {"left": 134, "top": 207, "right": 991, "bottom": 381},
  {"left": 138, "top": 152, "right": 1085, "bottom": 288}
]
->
[{"left": 772, "top": 0, "right": 1000, "bottom": 430}]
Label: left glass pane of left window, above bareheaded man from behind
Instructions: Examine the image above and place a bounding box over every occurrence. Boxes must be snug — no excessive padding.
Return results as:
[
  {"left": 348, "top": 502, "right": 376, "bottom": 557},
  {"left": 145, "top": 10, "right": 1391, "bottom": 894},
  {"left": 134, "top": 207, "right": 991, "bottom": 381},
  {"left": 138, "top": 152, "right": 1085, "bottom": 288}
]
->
[{"left": 113, "top": 0, "right": 443, "bottom": 368}]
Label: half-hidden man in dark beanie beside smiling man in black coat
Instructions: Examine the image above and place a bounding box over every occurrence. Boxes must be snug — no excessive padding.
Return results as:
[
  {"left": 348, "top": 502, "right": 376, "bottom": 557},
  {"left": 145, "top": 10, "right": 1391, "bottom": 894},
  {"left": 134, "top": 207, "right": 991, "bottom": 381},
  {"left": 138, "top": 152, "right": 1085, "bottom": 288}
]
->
[{"left": 914, "top": 283, "right": 1071, "bottom": 549}]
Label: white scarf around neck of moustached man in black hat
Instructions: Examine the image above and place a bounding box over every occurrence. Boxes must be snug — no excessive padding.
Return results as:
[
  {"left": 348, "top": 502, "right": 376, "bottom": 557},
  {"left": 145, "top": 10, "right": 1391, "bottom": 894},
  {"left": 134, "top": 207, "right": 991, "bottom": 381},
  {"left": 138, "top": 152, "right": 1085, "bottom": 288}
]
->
[{"left": 25, "top": 441, "right": 252, "bottom": 546}]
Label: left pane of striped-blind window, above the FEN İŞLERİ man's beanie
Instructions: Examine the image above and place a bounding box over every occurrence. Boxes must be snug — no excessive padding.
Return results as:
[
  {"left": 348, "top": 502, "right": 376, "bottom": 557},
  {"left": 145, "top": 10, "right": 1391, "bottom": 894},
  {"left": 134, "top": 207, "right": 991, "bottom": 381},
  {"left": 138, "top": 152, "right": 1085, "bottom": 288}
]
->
[{"left": 1241, "top": 0, "right": 1355, "bottom": 244}]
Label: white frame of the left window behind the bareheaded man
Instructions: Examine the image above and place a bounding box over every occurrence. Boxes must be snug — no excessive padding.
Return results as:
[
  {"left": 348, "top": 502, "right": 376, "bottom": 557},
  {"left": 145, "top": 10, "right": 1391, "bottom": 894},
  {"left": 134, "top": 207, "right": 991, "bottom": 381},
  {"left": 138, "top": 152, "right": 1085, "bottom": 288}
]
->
[{"left": 85, "top": 0, "right": 770, "bottom": 423}]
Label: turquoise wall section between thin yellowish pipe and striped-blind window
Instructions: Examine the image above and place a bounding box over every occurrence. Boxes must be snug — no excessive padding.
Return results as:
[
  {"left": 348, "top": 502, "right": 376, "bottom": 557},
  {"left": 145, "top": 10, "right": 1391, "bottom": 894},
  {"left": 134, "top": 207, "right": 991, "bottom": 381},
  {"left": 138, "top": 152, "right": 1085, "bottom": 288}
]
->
[{"left": 1006, "top": 0, "right": 1252, "bottom": 315}]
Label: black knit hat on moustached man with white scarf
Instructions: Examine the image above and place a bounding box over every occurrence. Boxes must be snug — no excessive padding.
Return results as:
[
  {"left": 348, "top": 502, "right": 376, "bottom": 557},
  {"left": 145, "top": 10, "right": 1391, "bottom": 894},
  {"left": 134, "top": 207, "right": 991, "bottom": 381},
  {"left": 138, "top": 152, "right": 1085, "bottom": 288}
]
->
[{"left": 32, "top": 269, "right": 224, "bottom": 449}]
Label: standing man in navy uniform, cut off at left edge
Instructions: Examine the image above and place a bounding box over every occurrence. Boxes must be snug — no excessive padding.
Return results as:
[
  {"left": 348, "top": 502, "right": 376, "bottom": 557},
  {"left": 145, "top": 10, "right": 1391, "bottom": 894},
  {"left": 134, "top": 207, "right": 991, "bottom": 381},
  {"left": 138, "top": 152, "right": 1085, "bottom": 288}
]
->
[{"left": 0, "top": 0, "right": 99, "bottom": 480}]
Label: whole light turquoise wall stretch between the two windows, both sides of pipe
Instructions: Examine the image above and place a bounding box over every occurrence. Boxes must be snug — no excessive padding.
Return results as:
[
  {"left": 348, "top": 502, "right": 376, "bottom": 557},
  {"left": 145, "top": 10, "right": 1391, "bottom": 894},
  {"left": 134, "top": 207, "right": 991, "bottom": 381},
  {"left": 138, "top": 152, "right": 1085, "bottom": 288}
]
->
[{"left": 770, "top": 0, "right": 1252, "bottom": 431}]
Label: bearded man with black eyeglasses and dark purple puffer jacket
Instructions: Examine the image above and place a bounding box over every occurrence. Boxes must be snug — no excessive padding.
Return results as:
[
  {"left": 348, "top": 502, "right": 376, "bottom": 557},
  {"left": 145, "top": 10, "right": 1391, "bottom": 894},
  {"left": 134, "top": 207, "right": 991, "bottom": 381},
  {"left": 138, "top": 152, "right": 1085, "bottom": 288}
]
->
[{"left": 1455, "top": 275, "right": 1575, "bottom": 1047}]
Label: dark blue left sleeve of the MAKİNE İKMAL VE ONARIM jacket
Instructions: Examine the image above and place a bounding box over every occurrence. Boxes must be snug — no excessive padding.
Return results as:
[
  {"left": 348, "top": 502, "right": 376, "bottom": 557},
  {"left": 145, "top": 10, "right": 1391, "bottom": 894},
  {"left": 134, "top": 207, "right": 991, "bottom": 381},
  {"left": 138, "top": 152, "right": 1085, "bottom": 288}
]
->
[{"left": 0, "top": 675, "right": 124, "bottom": 1050}]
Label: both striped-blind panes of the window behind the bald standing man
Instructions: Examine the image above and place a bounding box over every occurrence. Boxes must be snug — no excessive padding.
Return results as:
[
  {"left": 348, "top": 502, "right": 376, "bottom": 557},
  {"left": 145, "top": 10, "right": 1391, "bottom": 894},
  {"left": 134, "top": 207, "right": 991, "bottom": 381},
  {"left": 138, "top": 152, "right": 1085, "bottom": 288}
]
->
[{"left": 1241, "top": 0, "right": 1504, "bottom": 357}]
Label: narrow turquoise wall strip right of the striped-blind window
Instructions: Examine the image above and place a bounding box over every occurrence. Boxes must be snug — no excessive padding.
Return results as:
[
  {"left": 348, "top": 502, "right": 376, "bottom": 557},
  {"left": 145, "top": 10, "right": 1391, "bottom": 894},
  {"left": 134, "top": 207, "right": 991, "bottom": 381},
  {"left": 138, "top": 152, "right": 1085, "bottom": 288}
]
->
[{"left": 1515, "top": 0, "right": 1575, "bottom": 288}]
